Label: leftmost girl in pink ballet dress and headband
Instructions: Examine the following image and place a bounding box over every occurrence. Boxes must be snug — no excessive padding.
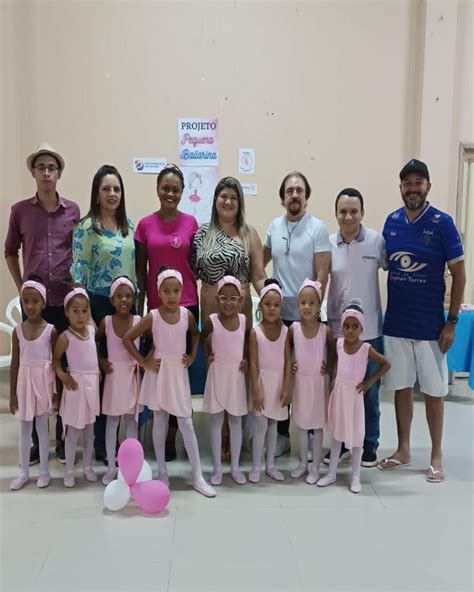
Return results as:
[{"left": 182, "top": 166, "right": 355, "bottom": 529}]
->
[{"left": 10, "top": 279, "right": 58, "bottom": 490}]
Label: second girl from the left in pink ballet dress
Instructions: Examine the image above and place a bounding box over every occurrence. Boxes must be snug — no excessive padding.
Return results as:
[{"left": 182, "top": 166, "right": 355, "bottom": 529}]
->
[{"left": 53, "top": 288, "right": 100, "bottom": 487}]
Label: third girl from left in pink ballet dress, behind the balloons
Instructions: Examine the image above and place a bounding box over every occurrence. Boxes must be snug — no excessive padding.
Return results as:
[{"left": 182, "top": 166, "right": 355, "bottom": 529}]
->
[{"left": 97, "top": 276, "right": 141, "bottom": 485}]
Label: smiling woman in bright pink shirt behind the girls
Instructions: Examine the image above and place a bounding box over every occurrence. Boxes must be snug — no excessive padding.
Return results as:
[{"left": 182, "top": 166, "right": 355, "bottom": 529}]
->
[{"left": 135, "top": 164, "right": 199, "bottom": 461}]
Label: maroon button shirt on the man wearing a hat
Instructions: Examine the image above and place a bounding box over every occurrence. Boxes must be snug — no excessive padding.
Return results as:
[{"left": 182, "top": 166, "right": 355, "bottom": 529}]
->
[{"left": 5, "top": 196, "right": 80, "bottom": 306}]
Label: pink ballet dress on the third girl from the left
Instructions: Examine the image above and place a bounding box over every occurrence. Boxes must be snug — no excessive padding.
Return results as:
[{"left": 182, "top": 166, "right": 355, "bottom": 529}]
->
[{"left": 102, "top": 316, "right": 142, "bottom": 419}]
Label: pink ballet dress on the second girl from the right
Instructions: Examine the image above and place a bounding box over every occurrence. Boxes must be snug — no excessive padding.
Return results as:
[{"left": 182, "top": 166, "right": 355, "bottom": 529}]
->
[{"left": 292, "top": 323, "right": 329, "bottom": 430}]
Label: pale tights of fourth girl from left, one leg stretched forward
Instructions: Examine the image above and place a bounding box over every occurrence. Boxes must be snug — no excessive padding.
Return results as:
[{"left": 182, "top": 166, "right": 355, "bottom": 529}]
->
[{"left": 153, "top": 411, "right": 204, "bottom": 485}]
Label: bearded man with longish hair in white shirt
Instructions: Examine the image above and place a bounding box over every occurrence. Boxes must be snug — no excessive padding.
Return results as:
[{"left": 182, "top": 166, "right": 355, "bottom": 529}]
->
[{"left": 264, "top": 171, "right": 330, "bottom": 456}]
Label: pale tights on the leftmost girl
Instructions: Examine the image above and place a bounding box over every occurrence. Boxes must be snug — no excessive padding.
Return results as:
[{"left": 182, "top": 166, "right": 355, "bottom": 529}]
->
[{"left": 10, "top": 413, "right": 50, "bottom": 490}]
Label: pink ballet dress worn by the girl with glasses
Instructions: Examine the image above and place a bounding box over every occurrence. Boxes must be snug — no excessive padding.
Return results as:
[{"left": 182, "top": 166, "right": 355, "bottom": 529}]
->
[{"left": 203, "top": 313, "right": 248, "bottom": 417}]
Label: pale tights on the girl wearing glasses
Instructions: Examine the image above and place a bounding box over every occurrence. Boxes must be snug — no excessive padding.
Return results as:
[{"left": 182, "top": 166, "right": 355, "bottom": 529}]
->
[{"left": 211, "top": 411, "right": 247, "bottom": 485}]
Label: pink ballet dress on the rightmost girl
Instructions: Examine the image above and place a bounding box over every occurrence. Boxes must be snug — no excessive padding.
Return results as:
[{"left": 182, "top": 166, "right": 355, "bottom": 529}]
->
[{"left": 327, "top": 338, "right": 370, "bottom": 448}]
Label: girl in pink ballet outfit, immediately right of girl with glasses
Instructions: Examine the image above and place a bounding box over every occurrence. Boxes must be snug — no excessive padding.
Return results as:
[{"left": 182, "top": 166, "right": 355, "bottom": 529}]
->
[{"left": 249, "top": 279, "right": 291, "bottom": 483}]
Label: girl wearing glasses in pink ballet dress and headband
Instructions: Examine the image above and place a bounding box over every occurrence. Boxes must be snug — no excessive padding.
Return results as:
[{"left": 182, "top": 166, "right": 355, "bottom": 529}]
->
[{"left": 202, "top": 275, "right": 251, "bottom": 485}]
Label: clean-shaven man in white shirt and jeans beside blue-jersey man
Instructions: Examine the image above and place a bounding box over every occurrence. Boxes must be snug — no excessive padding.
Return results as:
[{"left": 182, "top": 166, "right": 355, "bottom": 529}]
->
[{"left": 324, "top": 188, "right": 387, "bottom": 467}]
